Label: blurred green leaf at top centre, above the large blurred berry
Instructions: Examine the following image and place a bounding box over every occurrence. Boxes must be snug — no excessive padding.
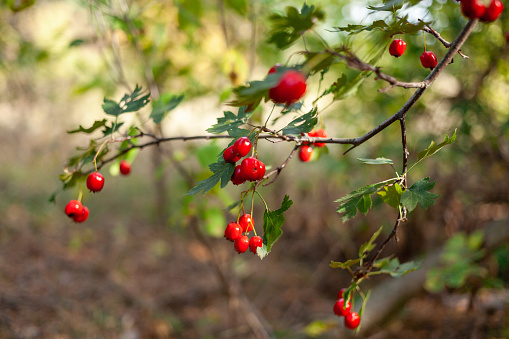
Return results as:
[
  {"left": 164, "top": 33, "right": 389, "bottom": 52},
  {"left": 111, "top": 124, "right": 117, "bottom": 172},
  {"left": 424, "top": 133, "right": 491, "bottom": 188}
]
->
[{"left": 267, "top": 3, "right": 325, "bottom": 49}]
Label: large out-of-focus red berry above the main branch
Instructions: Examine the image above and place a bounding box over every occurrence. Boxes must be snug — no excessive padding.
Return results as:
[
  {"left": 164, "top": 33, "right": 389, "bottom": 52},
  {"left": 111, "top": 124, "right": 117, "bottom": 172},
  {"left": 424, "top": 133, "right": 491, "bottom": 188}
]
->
[{"left": 269, "top": 70, "right": 306, "bottom": 105}]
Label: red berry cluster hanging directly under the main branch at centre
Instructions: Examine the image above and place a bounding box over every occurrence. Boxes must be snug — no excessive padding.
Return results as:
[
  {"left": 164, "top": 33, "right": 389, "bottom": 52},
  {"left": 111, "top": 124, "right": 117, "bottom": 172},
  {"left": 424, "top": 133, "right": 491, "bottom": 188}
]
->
[{"left": 223, "top": 137, "right": 265, "bottom": 185}]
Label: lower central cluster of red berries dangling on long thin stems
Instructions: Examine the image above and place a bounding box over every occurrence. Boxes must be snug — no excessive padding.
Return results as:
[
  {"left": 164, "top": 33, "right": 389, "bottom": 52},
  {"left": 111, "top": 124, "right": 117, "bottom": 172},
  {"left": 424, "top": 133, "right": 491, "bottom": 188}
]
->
[{"left": 224, "top": 214, "right": 263, "bottom": 254}]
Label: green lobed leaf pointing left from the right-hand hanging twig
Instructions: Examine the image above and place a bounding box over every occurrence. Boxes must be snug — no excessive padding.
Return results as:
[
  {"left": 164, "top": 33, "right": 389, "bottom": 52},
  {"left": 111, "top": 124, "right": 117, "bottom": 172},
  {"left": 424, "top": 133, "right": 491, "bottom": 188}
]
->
[{"left": 335, "top": 182, "right": 389, "bottom": 222}]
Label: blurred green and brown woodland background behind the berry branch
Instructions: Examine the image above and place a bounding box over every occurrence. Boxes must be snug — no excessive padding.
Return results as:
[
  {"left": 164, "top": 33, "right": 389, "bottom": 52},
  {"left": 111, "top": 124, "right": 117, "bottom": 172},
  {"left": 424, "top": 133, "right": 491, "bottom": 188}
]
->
[{"left": 0, "top": 0, "right": 509, "bottom": 339}]
